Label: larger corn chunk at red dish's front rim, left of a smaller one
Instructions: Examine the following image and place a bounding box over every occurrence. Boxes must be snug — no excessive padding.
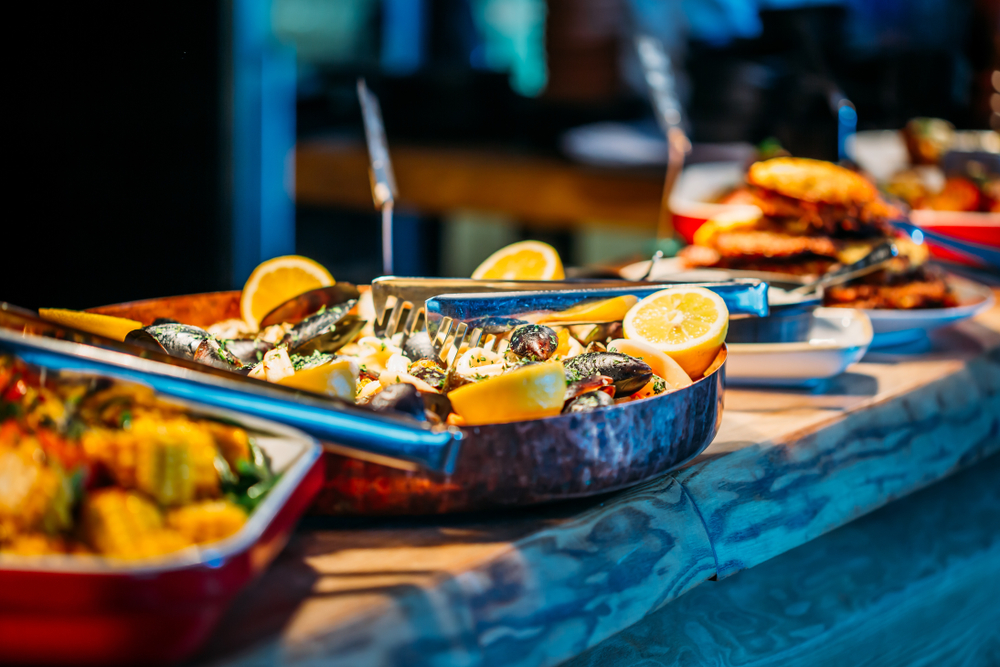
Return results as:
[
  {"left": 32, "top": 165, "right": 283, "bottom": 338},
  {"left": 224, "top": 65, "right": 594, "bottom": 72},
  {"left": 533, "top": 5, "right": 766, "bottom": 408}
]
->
[{"left": 82, "top": 488, "right": 190, "bottom": 558}]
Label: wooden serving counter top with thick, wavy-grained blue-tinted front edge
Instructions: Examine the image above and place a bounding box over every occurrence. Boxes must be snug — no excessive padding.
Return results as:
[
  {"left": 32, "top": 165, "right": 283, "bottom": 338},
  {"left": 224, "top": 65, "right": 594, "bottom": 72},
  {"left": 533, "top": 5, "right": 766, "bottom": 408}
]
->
[{"left": 201, "top": 292, "right": 1000, "bottom": 666}]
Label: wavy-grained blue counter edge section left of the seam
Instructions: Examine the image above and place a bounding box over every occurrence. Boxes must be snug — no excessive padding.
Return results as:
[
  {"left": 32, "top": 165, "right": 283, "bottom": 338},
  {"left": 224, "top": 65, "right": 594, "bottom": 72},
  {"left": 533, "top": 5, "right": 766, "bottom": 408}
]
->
[{"left": 282, "top": 478, "right": 715, "bottom": 666}]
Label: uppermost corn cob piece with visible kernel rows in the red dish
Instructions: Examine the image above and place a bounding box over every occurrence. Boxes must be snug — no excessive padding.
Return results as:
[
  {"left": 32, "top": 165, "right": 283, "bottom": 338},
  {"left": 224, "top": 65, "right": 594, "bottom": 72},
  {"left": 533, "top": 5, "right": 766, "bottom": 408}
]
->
[{"left": 83, "top": 415, "right": 219, "bottom": 506}]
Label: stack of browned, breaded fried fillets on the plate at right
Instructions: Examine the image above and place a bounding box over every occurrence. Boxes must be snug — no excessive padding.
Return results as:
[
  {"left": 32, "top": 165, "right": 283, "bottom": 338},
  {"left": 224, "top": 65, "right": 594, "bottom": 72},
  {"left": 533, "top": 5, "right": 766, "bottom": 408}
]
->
[{"left": 682, "top": 157, "right": 954, "bottom": 309}]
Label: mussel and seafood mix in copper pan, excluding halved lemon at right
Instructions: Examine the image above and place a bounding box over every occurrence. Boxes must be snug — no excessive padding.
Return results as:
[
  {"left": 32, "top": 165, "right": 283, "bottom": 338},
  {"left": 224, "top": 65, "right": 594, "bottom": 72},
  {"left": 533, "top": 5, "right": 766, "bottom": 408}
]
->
[{"left": 115, "top": 293, "right": 721, "bottom": 425}]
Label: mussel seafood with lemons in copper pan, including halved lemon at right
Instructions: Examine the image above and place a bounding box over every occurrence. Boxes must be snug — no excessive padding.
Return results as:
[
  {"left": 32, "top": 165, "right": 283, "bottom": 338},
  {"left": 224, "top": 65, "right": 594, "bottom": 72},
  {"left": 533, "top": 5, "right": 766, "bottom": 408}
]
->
[{"left": 40, "top": 253, "right": 728, "bottom": 426}]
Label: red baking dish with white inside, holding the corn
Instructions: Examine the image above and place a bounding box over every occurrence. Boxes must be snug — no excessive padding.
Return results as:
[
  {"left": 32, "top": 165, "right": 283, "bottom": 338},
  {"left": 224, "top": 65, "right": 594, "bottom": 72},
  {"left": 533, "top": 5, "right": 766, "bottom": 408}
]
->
[{"left": 0, "top": 352, "right": 323, "bottom": 665}]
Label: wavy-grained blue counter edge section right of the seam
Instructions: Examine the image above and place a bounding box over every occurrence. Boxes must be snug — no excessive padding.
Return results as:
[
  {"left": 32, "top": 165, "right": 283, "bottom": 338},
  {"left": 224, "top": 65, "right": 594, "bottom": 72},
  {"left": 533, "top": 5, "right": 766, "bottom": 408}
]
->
[{"left": 676, "top": 349, "right": 1000, "bottom": 578}]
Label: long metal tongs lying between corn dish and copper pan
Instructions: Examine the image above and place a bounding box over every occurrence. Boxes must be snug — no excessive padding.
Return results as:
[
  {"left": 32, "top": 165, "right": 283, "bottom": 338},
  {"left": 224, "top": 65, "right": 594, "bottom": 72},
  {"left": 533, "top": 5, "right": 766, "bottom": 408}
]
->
[{"left": 0, "top": 302, "right": 462, "bottom": 474}]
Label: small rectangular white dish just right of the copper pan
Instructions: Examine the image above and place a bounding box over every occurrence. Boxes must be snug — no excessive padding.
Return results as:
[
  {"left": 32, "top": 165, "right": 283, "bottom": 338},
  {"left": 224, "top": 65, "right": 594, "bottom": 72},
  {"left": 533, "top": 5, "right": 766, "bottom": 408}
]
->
[{"left": 726, "top": 308, "right": 873, "bottom": 387}]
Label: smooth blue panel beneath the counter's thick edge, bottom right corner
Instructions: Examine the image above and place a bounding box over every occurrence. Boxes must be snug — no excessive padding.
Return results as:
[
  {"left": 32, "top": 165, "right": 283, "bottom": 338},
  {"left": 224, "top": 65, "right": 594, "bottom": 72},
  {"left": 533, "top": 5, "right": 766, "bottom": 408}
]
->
[{"left": 566, "top": 456, "right": 1000, "bottom": 667}]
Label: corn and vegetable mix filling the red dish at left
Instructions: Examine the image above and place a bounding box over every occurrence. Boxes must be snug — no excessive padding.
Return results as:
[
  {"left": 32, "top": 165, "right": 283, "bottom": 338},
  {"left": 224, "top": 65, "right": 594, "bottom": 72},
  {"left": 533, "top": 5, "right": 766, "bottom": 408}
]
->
[{"left": 0, "top": 354, "right": 279, "bottom": 560}]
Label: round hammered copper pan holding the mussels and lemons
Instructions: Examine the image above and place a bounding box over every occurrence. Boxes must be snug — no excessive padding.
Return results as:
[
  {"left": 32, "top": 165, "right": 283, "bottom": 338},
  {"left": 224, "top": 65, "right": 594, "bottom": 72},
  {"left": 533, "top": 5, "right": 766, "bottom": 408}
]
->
[{"left": 91, "top": 291, "right": 726, "bottom": 515}]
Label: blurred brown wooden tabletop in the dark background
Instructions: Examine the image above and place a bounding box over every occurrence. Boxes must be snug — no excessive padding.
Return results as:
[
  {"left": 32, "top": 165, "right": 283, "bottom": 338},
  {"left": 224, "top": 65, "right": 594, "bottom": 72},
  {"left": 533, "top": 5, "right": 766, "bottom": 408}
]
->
[{"left": 295, "top": 139, "right": 663, "bottom": 233}]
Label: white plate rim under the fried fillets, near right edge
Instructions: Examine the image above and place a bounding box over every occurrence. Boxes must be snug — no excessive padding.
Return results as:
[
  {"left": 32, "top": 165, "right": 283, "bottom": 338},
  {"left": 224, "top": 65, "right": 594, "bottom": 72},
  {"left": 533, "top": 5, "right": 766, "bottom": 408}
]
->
[{"left": 864, "top": 274, "right": 994, "bottom": 348}]
